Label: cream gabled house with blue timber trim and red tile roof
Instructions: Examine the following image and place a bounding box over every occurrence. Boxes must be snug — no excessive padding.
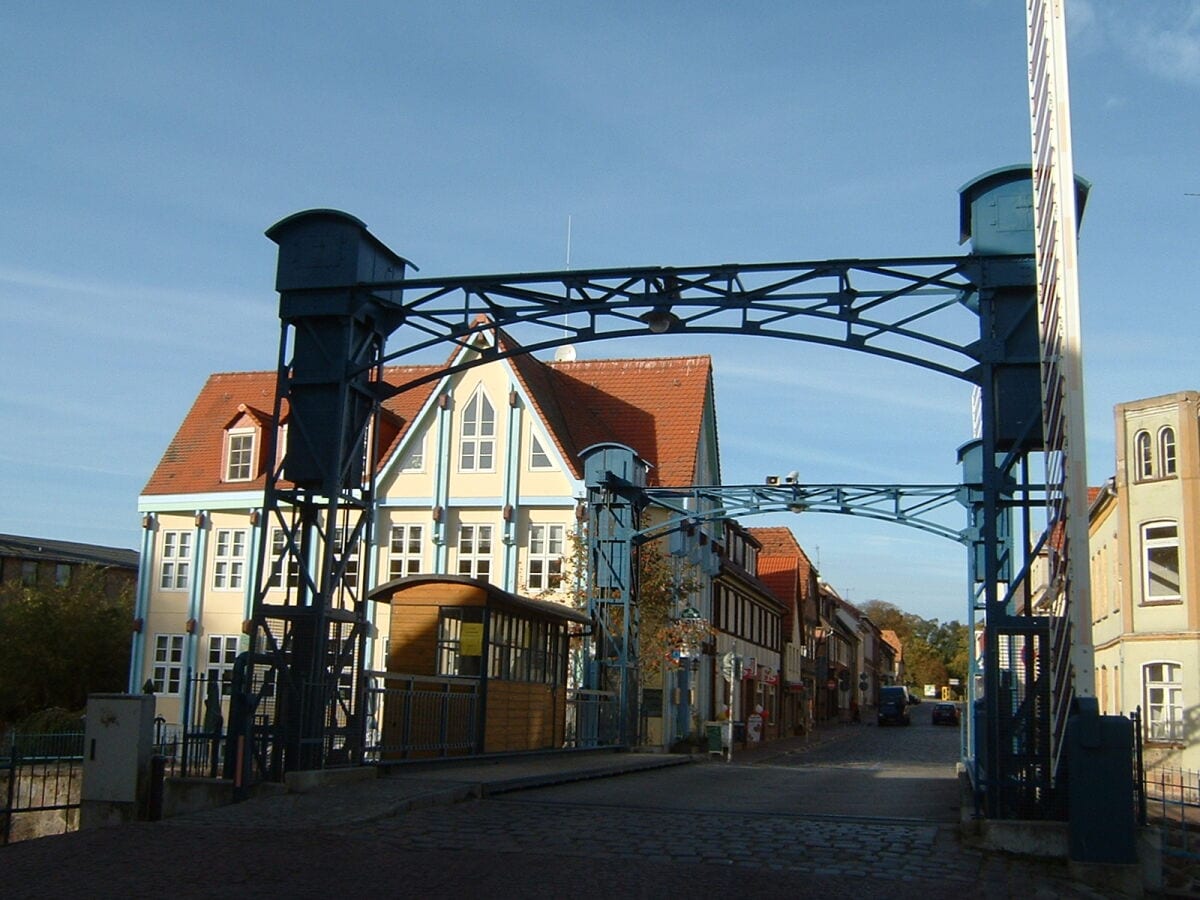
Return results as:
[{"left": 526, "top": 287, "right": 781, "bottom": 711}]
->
[{"left": 130, "top": 329, "right": 720, "bottom": 727}]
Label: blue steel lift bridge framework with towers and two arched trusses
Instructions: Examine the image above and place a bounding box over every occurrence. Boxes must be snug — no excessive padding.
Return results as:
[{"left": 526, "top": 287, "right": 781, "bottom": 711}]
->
[{"left": 223, "top": 167, "right": 1091, "bottom": 817}]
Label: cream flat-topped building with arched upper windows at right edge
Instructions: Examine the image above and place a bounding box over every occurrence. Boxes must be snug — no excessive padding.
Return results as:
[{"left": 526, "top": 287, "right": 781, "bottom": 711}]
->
[{"left": 1088, "top": 391, "right": 1200, "bottom": 769}]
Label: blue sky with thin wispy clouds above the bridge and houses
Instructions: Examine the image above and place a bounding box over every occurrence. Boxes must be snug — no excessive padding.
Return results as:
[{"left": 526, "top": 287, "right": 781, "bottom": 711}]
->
[{"left": 0, "top": 0, "right": 1200, "bottom": 620}]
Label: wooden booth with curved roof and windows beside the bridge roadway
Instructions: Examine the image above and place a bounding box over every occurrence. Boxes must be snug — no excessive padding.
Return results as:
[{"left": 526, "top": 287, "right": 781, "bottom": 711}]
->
[{"left": 370, "top": 575, "right": 592, "bottom": 761}]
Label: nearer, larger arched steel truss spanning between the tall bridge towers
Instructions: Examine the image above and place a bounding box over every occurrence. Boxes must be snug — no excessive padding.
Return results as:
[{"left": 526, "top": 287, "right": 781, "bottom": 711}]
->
[{"left": 370, "top": 256, "right": 1033, "bottom": 390}]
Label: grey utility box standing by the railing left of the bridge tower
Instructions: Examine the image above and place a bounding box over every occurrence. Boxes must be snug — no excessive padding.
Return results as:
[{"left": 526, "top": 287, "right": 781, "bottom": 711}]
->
[{"left": 79, "top": 694, "right": 155, "bottom": 828}]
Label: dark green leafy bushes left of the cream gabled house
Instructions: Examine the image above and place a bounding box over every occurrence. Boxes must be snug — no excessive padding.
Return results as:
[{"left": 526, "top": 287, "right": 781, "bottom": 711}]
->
[{"left": 0, "top": 566, "right": 133, "bottom": 724}]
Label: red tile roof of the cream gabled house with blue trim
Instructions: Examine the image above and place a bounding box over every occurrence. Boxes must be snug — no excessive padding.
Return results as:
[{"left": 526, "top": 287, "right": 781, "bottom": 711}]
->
[{"left": 143, "top": 329, "right": 713, "bottom": 494}]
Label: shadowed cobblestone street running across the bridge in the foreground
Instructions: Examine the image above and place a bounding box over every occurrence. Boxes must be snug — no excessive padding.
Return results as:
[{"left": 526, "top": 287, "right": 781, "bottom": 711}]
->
[{"left": 0, "top": 726, "right": 1123, "bottom": 900}]
